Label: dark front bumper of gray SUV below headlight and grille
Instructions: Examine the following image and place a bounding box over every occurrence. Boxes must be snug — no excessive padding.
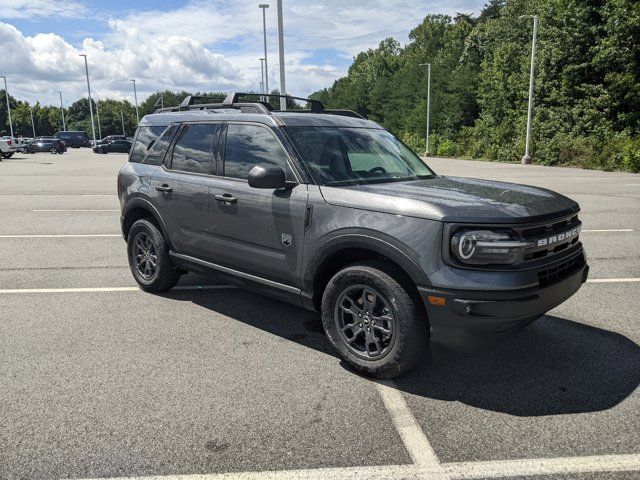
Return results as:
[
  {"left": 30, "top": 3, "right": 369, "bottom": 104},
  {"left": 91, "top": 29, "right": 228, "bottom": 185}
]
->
[{"left": 418, "top": 262, "right": 589, "bottom": 344}]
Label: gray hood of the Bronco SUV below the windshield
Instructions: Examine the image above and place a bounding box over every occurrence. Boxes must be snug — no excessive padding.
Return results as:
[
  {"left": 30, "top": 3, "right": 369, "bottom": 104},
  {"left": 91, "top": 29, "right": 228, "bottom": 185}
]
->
[{"left": 320, "top": 176, "right": 580, "bottom": 223}]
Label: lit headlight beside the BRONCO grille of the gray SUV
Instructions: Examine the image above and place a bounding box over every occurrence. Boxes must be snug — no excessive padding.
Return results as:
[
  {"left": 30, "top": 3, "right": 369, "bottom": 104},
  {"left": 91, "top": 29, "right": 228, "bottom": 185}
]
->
[{"left": 451, "top": 229, "right": 529, "bottom": 265}]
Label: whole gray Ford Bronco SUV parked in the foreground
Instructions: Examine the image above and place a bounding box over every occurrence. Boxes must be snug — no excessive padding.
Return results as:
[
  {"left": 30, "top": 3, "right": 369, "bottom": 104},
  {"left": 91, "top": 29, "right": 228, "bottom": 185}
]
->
[{"left": 118, "top": 94, "right": 588, "bottom": 377}]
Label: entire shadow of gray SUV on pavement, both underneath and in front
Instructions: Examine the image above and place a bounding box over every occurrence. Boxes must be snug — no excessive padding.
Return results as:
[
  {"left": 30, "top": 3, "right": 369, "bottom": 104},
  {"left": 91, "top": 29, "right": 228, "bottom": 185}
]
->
[{"left": 164, "top": 289, "right": 640, "bottom": 416}]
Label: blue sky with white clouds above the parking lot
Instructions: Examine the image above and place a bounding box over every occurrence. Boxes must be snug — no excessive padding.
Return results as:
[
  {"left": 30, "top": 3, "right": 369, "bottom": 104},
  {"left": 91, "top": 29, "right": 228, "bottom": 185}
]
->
[{"left": 0, "top": 0, "right": 486, "bottom": 106}]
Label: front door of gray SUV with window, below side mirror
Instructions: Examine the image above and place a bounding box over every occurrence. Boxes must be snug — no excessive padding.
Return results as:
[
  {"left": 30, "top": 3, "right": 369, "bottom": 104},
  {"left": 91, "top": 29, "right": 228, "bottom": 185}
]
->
[{"left": 209, "top": 123, "right": 307, "bottom": 286}]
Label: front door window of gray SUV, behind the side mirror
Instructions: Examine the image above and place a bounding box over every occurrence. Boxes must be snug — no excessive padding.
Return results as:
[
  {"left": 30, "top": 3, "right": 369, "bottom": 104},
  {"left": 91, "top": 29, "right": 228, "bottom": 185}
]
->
[{"left": 224, "top": 124, "right": 293, "bottom": 180}]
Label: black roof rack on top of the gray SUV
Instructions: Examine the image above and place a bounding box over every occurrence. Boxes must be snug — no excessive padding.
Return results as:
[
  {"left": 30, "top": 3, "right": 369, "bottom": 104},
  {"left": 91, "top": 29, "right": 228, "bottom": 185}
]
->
[{"left": 155, "top": 92, "right": 364, "bottom": 118}]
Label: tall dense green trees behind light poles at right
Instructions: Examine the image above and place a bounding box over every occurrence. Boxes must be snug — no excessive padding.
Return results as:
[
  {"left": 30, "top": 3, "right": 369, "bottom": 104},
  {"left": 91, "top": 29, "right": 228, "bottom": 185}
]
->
[{"left": 312, "top": 0, "right": 640, "bottom": 172}]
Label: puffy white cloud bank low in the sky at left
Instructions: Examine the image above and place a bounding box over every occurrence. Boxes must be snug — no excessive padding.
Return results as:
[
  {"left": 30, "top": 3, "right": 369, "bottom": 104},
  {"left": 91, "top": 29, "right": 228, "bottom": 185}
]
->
[{"left": 0, "top": 22, "right": 251, "bottom": 103}]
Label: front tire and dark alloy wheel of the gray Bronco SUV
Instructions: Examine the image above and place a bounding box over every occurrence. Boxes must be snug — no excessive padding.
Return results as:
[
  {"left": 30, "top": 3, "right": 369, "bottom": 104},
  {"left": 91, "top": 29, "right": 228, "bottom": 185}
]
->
[{"left": 321, "top": 261, "right": 429, "bottom": 378}]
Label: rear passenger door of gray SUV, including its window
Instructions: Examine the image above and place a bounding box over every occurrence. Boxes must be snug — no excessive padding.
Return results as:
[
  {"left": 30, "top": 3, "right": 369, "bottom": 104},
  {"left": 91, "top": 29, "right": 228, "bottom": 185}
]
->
[{"left": 151, "top": 123, "right": 221, "bottom": 259}]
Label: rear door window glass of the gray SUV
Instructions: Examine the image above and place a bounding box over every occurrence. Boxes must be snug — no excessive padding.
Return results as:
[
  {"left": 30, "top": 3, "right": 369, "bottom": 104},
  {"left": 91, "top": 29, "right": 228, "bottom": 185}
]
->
[{"left": 171, "top": 124, "right": 220, "bottom": 173}]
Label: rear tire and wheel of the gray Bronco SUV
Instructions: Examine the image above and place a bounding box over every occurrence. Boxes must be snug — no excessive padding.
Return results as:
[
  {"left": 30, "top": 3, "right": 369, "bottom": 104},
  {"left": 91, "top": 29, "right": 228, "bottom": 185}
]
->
[{"left": 127, "top": 219, "right": 180, "bottom": 293}]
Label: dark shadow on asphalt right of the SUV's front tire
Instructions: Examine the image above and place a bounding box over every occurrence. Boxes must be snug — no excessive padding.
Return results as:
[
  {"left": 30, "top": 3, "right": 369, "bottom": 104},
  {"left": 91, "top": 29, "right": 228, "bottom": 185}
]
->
[{"left": 397, "top": 316, "right": 640, "bottom": 417}]
